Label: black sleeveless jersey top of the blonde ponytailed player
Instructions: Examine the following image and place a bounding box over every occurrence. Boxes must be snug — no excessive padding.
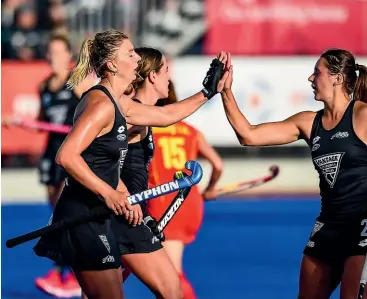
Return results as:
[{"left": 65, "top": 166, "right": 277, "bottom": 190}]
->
[{"left": 68, "top": 85, "right": 128, "bottom": 189}]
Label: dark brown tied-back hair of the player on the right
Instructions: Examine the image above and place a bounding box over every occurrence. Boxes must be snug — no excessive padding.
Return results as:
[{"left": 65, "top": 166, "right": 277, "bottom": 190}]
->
[{"left": 321, "top": 49, "right": 367, "bottom": 102}]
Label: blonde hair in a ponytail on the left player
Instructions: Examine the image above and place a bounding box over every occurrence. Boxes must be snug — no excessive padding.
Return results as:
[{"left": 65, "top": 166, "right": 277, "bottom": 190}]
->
[{"left": 67, "top": 30, "right": 128, "bottom": 89}]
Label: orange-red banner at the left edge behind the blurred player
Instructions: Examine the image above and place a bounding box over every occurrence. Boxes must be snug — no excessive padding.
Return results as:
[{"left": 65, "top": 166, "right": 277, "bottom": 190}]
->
[{"left": 1, "top": 61, "right": 50, "bottom": 154}]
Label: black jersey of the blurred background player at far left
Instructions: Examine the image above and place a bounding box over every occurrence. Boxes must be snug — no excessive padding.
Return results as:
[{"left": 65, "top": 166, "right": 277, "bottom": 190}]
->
[{"left": 39, "top": 75, "right": 79, "bottom": 140}]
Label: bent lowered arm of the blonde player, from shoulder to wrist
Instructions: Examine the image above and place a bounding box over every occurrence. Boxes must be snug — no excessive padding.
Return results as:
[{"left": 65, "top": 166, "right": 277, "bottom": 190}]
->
[{"left": 56, "top": 99, "right": 114, "bottom": 197}]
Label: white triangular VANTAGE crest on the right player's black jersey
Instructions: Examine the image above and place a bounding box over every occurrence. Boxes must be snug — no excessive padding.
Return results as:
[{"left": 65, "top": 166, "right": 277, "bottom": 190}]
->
[{"left": 313, "top": 153, "right": 345, "bottom": 188}]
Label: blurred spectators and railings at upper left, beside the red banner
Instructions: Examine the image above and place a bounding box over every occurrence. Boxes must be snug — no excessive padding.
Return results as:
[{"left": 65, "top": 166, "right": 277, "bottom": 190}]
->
[{"left": 1, "top": 0, "right": 204, "bottom": 61}]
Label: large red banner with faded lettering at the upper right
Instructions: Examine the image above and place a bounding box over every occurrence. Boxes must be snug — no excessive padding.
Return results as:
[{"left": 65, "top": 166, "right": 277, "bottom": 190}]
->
[{"left": 205, "top": 0, "right": 367, "bottom": 55}]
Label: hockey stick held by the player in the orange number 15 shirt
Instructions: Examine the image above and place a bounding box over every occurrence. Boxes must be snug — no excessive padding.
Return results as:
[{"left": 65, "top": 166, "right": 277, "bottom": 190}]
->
[{"left": 209, "top": 166, "right": 279, "bottom": 200}]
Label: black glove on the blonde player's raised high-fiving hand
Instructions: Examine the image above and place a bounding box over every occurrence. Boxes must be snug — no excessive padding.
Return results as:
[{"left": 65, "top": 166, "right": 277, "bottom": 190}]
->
[{"left": 202, "top": 58, "right": 224, "bottom": 100}]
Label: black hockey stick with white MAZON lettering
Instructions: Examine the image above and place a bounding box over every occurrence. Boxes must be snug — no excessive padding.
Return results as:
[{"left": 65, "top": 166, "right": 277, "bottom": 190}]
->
[{"left": 122, "top": 171, "right": 191, "bottom": 282}]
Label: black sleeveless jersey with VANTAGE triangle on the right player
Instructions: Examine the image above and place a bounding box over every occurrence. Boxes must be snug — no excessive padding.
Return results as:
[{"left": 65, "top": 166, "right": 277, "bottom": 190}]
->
[{"left": 310, "top": 101, "right": 367, "bottom": 222}]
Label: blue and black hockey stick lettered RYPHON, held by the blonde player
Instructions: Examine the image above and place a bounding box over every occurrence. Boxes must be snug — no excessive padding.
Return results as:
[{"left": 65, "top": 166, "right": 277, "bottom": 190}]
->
[{"left": 6, "top": 161, "right": 203, "bottom": 248}]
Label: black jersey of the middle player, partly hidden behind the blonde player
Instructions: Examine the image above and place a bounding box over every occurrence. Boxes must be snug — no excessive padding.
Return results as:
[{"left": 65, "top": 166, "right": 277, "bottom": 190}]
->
[{"left": 120, "top": 99, "right": 154, "bottom": 205}]
